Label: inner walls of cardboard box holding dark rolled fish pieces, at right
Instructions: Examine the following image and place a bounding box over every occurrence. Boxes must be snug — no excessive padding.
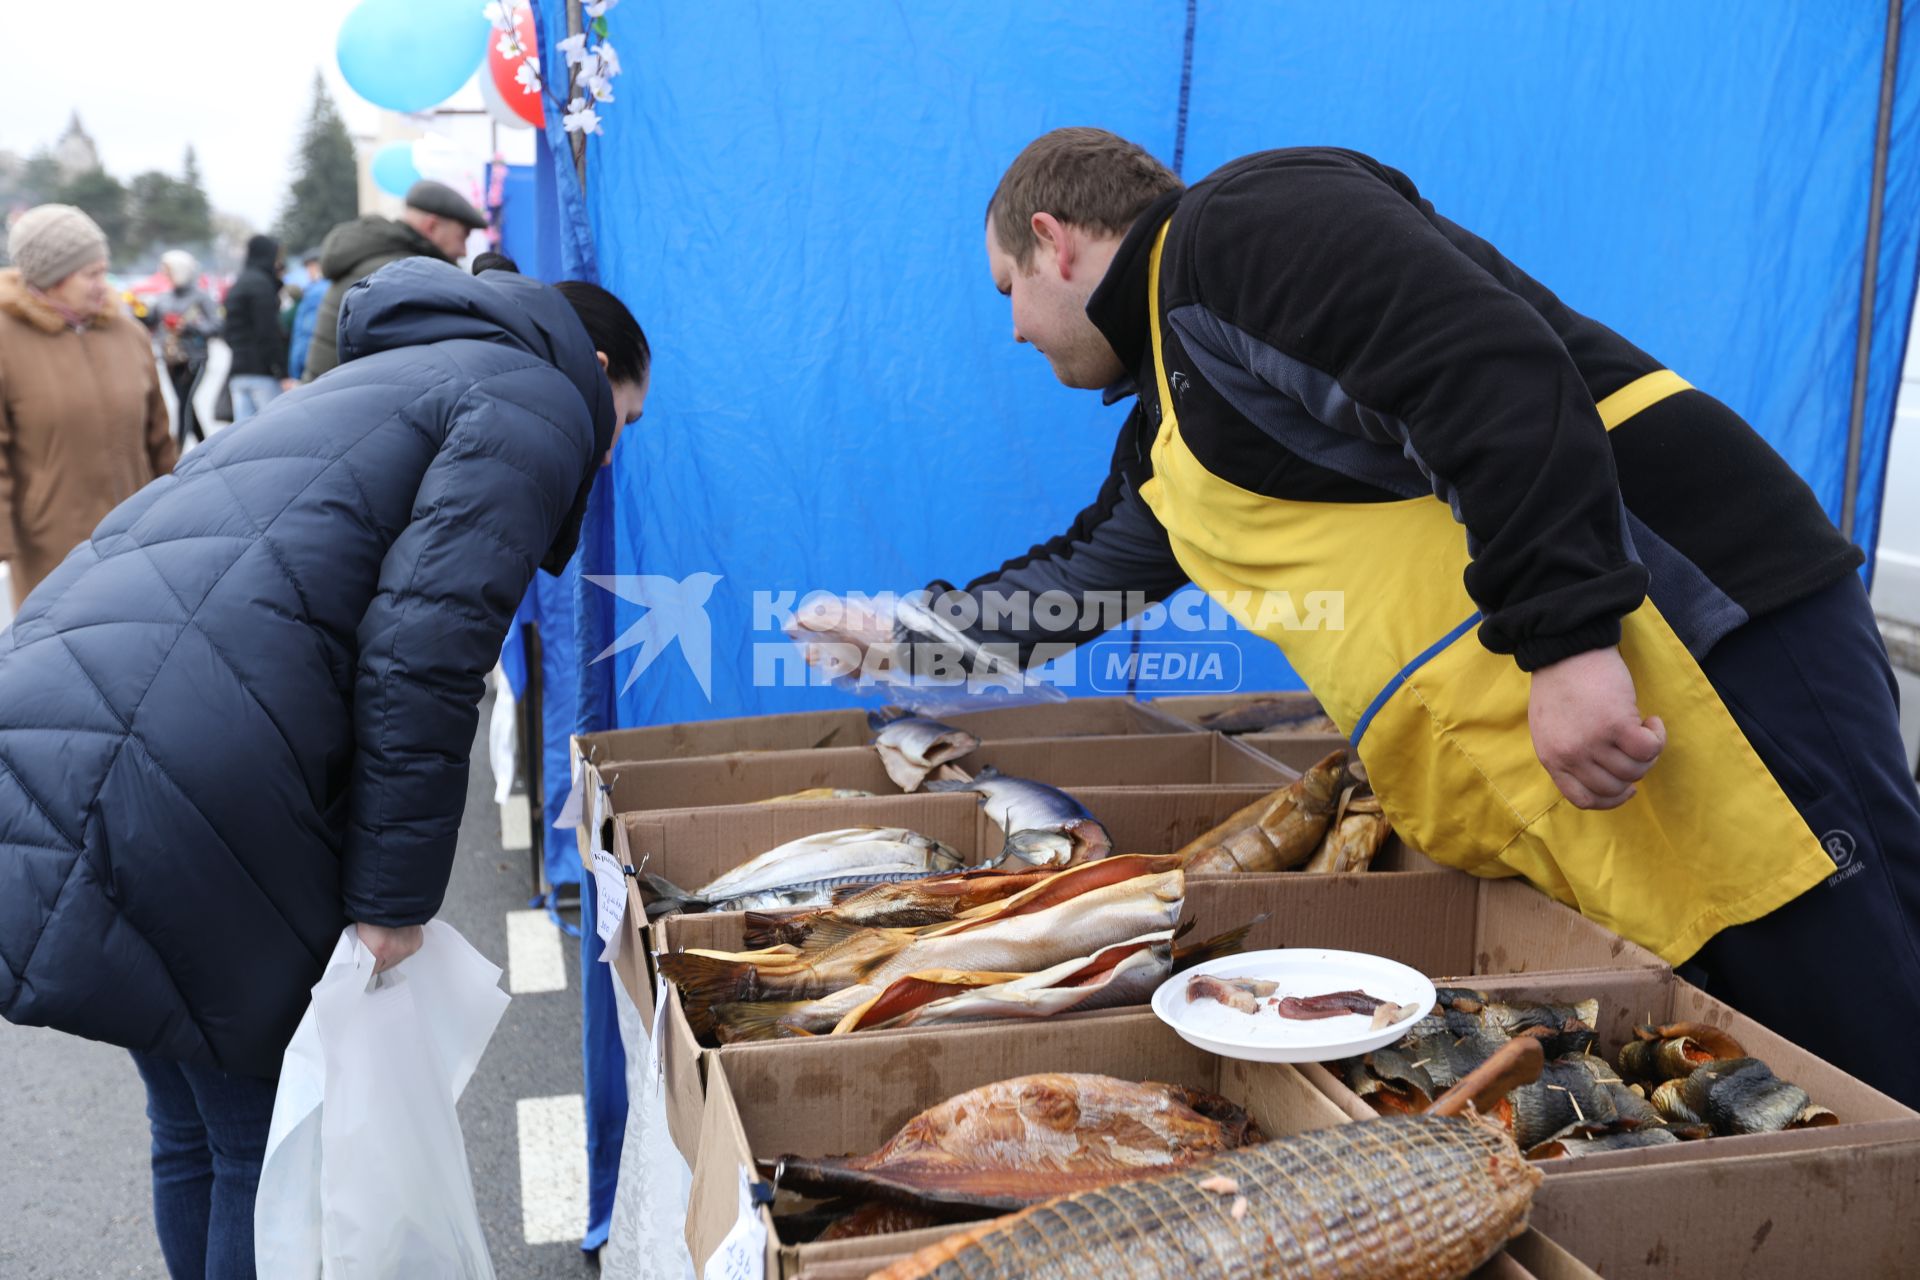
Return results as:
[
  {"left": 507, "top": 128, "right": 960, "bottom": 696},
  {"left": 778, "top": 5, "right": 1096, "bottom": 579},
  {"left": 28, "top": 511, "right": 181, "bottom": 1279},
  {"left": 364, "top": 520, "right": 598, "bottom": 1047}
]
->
[{"left": 1302, "top": 969, "right": 1920, "bottom": 1182}]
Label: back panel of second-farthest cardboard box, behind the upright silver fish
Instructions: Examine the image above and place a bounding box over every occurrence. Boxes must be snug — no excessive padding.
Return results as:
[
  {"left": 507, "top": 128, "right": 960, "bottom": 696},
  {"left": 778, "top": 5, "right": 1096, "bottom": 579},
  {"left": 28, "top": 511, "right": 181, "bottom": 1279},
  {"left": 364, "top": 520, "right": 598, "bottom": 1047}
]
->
[{"left": 599, "top": 733, "right": 1294, "bottom": 816}]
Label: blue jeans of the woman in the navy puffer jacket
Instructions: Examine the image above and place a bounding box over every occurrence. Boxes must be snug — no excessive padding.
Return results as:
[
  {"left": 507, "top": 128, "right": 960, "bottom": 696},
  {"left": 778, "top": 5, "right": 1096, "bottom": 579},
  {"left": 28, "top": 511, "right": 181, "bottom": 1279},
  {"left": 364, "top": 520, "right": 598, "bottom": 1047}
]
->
[{"left": 132, "top": 1054, "right": 276, "bottom": 1280}]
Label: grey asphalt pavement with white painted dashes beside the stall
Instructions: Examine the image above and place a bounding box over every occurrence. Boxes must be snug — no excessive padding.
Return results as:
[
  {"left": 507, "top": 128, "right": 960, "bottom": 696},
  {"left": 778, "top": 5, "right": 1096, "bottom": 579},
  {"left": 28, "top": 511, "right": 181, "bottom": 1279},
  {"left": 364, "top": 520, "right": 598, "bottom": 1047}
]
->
[{"left": 0, "top": 702, "right": 597, "bottom": 1280}]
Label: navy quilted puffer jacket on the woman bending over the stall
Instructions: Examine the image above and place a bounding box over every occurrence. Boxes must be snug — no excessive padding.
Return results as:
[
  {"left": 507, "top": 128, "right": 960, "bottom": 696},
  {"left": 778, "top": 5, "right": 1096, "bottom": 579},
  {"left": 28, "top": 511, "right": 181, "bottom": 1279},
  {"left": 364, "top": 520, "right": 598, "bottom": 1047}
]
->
[{"left": 0, "top": 259, "right": 614, "bottom": 1077}]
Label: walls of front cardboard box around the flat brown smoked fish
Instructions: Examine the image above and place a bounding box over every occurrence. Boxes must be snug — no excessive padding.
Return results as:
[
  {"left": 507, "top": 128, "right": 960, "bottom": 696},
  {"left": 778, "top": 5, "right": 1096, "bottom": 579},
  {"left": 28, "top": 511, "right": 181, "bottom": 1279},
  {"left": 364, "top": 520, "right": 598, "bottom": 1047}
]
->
[{"left": 687, "top": 1013, "right": 1592, "bottom": 1280}]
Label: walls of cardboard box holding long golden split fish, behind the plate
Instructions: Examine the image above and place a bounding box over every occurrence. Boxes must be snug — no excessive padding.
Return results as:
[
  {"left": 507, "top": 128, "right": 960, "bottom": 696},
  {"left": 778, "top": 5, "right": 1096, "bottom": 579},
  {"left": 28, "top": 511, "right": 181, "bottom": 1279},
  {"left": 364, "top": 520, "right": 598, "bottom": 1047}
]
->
[{"left": 643, "top": 859, "right": 1668, "bottom": 1161}]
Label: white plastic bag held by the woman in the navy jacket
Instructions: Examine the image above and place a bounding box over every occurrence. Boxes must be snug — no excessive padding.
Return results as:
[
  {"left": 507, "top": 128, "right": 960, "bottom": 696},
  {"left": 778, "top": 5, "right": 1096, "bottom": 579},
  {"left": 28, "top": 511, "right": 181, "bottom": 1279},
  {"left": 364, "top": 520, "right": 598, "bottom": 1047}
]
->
[{"left": 253, "top": 919, "right": 507, "bottom": 1280}]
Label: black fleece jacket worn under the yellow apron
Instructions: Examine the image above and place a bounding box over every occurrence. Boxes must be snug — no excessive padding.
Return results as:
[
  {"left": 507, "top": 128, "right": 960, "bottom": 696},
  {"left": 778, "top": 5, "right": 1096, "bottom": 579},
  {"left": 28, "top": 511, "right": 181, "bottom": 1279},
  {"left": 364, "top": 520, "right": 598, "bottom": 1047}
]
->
[{"left": 925, "top": 148, "right": 1860, "bottom": 670}]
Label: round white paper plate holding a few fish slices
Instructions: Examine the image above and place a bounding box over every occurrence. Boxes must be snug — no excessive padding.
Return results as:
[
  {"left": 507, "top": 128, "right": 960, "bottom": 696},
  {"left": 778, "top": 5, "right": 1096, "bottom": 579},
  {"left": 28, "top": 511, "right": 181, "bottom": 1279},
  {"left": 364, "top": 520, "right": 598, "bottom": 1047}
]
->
[{"left": 1154, "top": 948, "right": 1434, "bottom": 1063}]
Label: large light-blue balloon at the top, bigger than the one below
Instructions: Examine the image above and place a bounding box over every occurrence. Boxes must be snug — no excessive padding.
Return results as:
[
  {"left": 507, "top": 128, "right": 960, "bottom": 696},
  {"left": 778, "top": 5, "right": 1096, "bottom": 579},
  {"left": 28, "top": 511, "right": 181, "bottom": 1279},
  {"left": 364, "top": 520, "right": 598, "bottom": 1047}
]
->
[{"left": 334, "top": 0, "right": 493, "bottom": 111}]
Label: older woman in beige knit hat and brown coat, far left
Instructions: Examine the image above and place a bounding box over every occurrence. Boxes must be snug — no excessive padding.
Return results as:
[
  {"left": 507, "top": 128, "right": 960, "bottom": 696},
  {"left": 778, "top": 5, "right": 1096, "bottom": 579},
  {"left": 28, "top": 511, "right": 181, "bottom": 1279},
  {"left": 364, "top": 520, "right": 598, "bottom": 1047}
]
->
[{"left": 0, "top": 205, "right": 175, "bottom": 608}]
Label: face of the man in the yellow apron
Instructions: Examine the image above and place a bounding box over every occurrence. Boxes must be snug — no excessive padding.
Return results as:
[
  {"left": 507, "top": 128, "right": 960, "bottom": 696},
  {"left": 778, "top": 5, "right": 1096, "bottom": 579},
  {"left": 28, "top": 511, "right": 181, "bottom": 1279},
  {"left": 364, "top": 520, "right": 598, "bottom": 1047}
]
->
[{"left": 987, "top": 221, "right": 1127, "bottom": 390}]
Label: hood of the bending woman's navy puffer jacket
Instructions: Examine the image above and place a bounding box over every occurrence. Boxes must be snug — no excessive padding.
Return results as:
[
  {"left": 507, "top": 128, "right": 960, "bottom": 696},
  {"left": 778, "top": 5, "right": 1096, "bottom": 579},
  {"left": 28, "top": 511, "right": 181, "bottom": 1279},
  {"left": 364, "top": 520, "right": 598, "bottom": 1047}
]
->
[{"left": 340, "top": 257, "right": 614, "bottom": 574}]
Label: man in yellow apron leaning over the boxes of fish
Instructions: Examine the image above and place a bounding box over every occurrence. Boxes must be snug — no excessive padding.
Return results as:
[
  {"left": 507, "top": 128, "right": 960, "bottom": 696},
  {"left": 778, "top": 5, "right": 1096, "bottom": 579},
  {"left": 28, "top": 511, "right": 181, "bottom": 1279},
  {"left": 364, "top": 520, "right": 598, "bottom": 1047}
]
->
[{"left": 802, "top": 129, "right": 1920, "bottom": 1103}]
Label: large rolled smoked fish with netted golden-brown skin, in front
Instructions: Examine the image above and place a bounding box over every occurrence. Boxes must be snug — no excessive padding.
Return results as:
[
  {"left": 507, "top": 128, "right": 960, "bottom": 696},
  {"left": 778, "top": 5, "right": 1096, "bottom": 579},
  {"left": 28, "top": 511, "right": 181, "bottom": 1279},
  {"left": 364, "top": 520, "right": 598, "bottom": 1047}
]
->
[{"left": 870, "top": 1115, "right": 1542, "bottom": 1280}]
